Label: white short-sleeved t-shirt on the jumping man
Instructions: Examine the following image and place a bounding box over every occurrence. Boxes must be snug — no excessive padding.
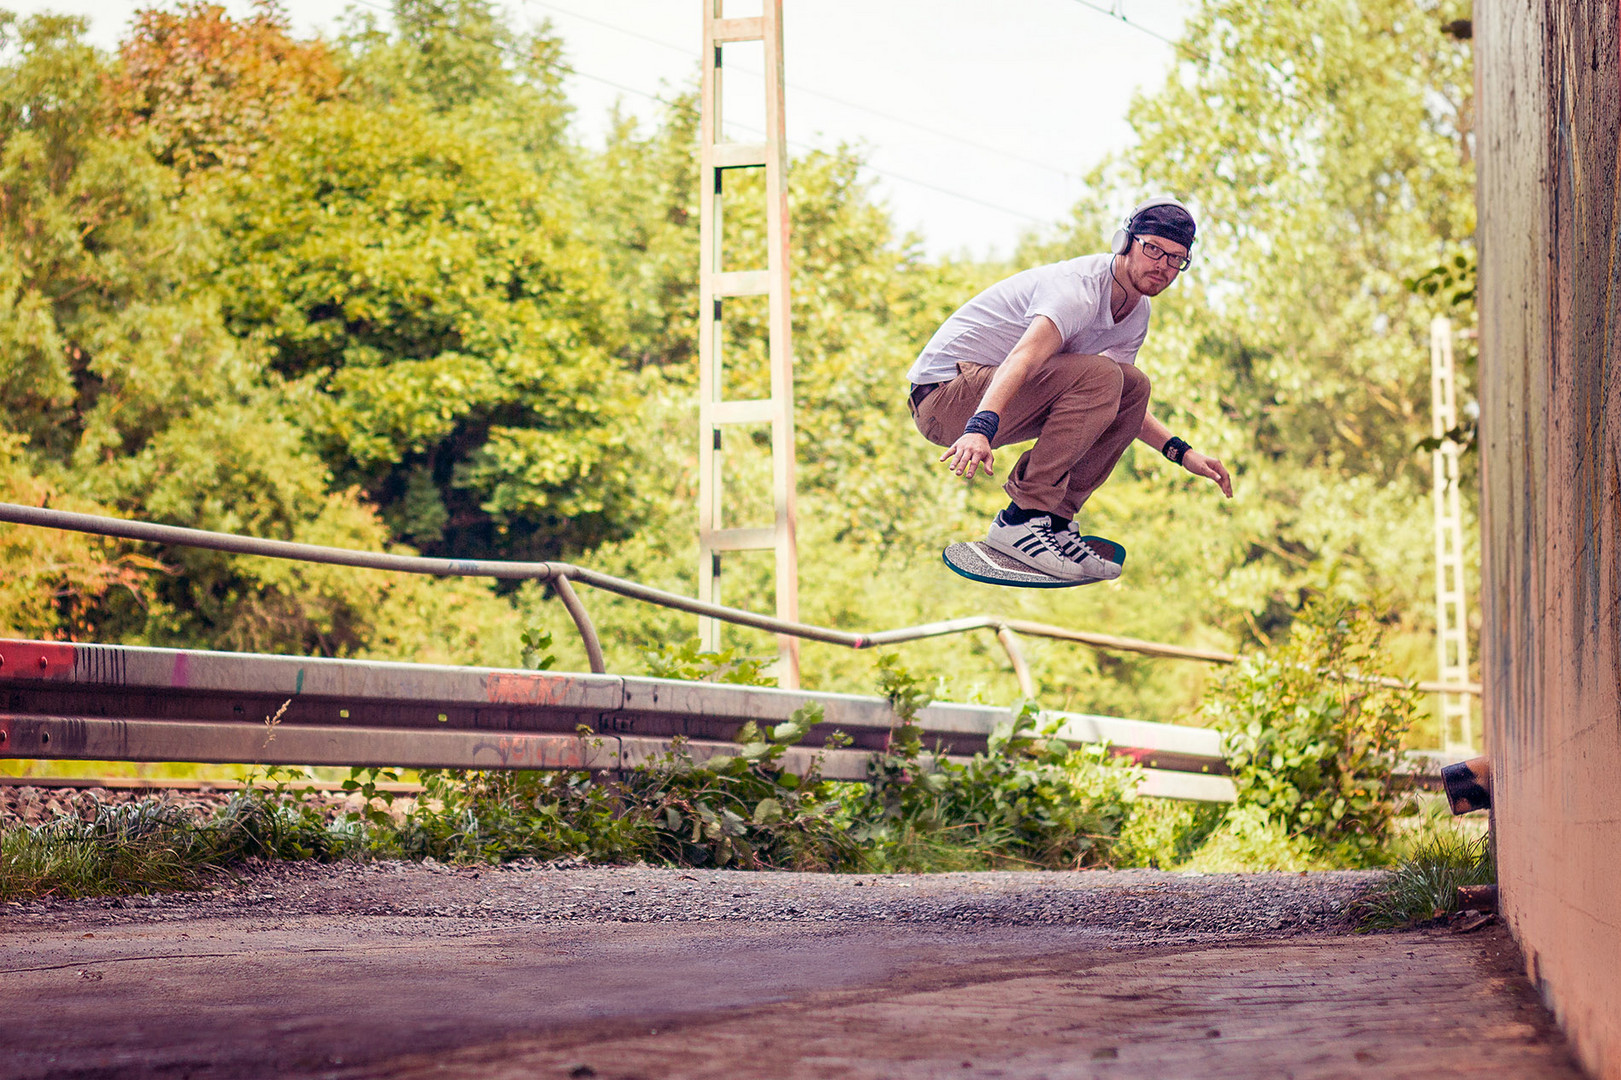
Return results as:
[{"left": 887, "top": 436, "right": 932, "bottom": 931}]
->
[{"left": 906, "top": 255, "right": 1148, "bottom": 384}]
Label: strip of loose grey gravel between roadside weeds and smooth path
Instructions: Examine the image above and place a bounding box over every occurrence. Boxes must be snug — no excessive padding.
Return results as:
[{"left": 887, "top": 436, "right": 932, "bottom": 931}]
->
[{"left": 0, "top": 859, "right": 1378, "bottom": 942}]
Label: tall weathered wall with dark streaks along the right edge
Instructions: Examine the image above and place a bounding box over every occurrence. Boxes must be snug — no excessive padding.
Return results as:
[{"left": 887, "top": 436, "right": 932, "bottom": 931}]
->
[{"left": 1475, "top": 0, "right": 1621, "bottom": 1080}]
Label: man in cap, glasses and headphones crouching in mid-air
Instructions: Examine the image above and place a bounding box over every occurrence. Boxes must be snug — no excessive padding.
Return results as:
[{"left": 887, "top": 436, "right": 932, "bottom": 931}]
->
[{"left": 906, "top": 198, "right": 1232, "bottom": 581}]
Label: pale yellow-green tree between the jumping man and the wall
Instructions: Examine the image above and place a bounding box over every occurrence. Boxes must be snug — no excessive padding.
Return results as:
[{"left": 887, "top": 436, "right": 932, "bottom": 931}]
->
[{"left": 1024, "top": 0, "right": 1473, "bottom": 723}]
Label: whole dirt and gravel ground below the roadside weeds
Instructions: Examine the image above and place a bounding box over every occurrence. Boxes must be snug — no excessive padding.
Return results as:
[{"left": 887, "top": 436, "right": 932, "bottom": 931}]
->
[{"left": 0, "top": 866, "right": 1579, "bottom": 1080}]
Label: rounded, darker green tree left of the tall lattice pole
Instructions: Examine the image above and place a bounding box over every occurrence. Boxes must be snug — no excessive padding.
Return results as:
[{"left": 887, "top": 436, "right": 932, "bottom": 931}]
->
[{"left": 219, "top": 3, "right": 640, "bottom": 558}]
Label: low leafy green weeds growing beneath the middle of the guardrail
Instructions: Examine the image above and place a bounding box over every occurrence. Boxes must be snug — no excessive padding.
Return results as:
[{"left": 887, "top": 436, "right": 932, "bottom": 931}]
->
[{"left": 384, "top": 652, "right": 1140, "bottom": 871}]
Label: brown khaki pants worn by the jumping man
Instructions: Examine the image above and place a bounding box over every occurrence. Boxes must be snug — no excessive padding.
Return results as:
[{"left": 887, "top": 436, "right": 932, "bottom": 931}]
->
[{"left": 913, "top": 352, "right": 1149, "bottom": 517}]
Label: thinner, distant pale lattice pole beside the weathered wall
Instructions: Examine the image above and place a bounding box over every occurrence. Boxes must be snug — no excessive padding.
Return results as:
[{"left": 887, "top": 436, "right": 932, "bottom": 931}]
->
[{"left": 1430, "top": 318, "right": 1475, "bottom": 754}]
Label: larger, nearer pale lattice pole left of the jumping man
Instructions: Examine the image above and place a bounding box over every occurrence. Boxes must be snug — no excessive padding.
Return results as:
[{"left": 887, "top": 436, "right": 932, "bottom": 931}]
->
[{"left": 699, "top": 0, "right": 799, "bottom": 688}]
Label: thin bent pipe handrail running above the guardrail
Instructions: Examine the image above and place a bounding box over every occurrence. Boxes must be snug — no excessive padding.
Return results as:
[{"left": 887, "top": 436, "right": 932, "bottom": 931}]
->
[{"left": 0, "top": 503, "right": 1480, "bottom": 697}]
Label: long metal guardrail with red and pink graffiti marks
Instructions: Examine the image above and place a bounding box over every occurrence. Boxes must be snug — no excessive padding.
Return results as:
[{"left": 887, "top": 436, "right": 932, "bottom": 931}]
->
[{"left": 0, "top": 641, "right": 1232, "bottom": 801}]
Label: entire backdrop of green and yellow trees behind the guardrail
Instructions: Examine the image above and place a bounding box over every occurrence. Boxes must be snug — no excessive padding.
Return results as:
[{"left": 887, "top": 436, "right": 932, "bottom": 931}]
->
[{"left": 0, "top": 0, "right": 1472, "bottom": 749}]
